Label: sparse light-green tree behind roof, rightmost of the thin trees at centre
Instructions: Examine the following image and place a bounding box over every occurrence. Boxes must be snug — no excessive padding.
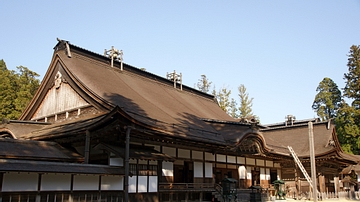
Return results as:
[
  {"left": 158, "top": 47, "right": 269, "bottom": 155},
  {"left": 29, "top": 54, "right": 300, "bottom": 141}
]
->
[{"left": 238, "top": 84, "right": 254, "bottom": 118}]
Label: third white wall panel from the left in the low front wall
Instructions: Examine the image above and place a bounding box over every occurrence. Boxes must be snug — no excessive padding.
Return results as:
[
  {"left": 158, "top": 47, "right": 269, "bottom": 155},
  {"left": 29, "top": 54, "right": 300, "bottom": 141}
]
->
[{"left": 73, "top": 175, "right": 99, "bottom": 190}]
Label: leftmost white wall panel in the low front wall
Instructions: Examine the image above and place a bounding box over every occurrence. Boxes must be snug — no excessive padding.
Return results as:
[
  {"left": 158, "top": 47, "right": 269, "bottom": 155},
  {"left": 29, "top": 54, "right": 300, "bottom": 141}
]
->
[{"left": 2, "top": 173, "right": 39, "bottom": 191}]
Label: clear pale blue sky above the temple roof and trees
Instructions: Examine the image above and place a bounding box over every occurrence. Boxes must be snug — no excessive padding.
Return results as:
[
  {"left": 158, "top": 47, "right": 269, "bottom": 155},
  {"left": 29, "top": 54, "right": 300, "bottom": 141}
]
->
[{"left": 0, "top": 0, "right": 360, "bottom": 124}]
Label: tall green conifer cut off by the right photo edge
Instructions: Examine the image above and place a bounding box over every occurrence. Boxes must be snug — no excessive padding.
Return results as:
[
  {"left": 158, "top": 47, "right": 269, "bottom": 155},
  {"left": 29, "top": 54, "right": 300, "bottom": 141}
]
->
[{"left": 335, "top": 45, "right": 360, "bottom": 154}]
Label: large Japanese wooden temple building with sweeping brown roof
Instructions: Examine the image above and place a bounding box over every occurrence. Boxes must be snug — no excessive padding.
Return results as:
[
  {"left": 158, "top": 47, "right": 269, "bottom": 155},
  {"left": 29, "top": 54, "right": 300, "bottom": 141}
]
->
[{"left": 0, "top": 40, "right": 360, "bottom": 202}]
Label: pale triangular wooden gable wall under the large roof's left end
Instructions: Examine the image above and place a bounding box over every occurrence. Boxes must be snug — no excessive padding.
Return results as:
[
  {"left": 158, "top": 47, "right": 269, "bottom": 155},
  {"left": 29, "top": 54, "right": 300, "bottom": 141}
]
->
[{"left": 32, "top": 79, "right": 89, "bottom": 119}]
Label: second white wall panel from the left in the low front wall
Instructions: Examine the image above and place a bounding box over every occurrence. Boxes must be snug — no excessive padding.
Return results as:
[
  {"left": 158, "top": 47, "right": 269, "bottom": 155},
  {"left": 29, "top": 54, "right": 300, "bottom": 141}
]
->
[{"left": 40, "top": 173, "right": 71, "bottom": 191}]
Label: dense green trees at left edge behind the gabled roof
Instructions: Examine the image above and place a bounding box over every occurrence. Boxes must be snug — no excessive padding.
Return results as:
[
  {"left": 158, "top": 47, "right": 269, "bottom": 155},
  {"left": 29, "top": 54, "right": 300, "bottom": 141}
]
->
[{"left": 0, "top": 60, "right": 40, "bottom": 120}]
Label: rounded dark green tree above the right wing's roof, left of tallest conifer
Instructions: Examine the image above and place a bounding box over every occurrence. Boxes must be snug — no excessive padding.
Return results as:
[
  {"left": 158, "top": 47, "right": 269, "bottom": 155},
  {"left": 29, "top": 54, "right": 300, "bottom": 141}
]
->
[{"left": 312, "top": 77, "right": 341, "bottom": 121}]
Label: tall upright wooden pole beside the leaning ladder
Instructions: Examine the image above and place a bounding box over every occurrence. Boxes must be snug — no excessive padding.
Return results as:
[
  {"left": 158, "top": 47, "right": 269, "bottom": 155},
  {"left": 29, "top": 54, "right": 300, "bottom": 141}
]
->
[{"left": 308, "top": 121, "right": 317, "bottom": 202}]
